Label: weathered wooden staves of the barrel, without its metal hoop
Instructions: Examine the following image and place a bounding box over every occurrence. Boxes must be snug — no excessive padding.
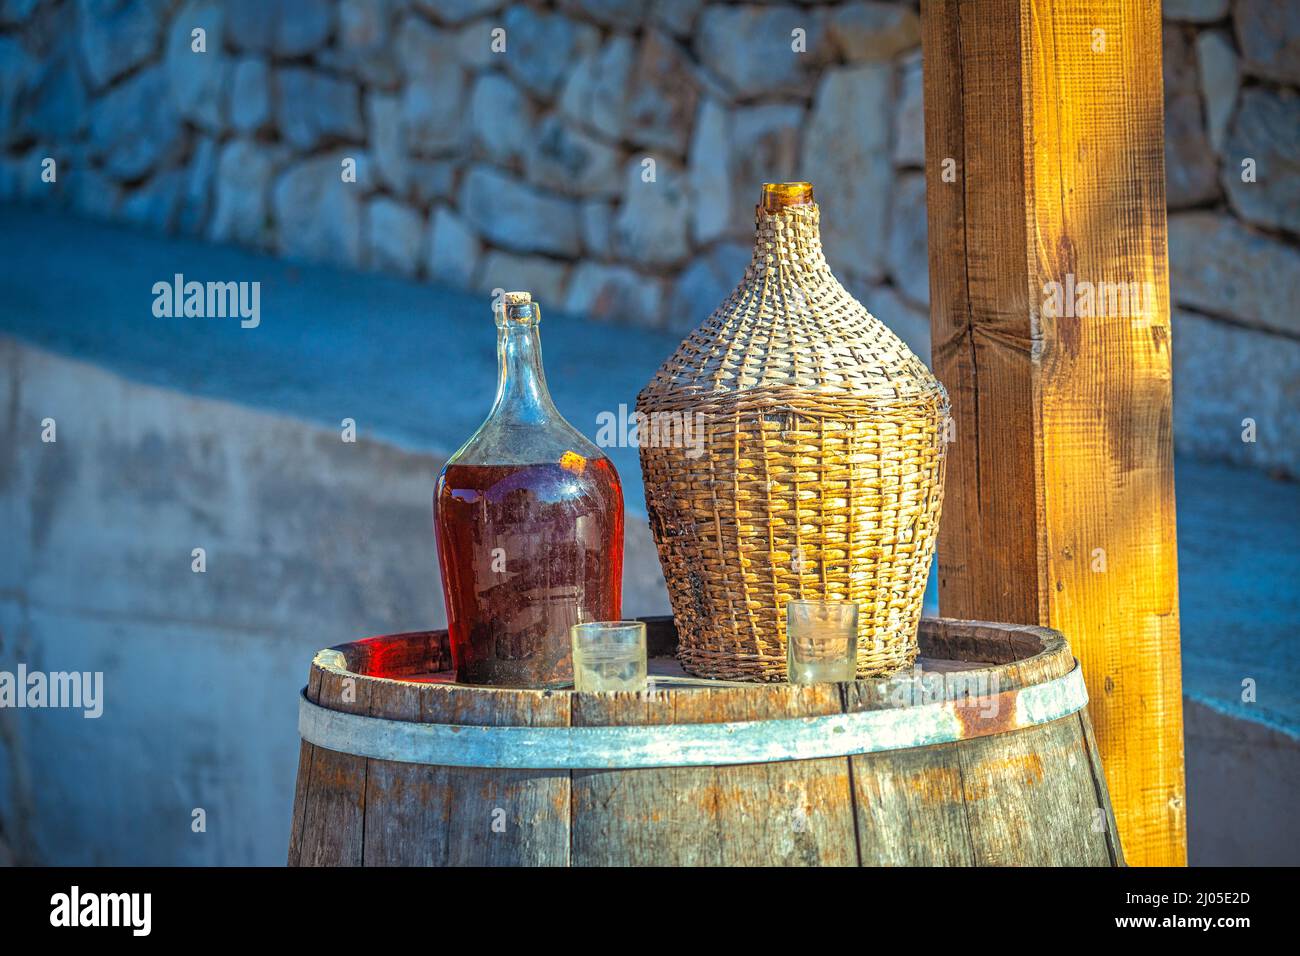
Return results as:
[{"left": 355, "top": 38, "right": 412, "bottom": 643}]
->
[{"left": 289, "top": 619, "right": 1122, "bottom": 866}]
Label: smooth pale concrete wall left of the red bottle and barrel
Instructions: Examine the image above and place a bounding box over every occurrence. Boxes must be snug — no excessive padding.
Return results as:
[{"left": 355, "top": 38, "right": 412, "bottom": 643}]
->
[{"left": 0, "top": 339, "right": 442, "bottom": 864}]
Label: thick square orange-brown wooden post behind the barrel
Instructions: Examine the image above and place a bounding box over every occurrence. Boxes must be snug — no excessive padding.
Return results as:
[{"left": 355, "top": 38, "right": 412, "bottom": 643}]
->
[{"left": 922, "top": 0, "right": 1187, "bottom": 865}]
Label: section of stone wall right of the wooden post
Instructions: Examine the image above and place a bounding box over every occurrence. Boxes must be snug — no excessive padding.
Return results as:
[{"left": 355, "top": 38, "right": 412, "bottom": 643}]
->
[{"left": 1165, "top": 0, "right": 1300, "bottom": 476}]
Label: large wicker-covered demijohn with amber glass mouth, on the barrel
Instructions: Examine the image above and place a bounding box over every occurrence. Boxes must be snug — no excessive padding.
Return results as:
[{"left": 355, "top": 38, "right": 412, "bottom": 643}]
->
[{"left": 637, "top": 183, "right": 949, "bottom": 680}]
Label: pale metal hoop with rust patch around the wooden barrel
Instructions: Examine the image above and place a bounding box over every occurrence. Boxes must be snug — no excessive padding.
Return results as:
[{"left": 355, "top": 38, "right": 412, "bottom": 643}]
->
[{"left": 298, "top": 662, "right": 1088, "bottom": 770}]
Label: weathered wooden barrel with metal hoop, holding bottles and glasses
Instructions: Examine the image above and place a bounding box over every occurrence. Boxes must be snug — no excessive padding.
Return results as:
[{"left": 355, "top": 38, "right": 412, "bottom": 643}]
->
[{"left": 289, "top": 618, "right": 1122, "bottom": 866}]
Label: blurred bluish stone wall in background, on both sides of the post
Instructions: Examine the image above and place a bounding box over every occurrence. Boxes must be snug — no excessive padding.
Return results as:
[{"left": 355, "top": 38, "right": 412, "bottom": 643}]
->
[{"left": 0, "top": 0, "right": 1300, "bottom": 473}]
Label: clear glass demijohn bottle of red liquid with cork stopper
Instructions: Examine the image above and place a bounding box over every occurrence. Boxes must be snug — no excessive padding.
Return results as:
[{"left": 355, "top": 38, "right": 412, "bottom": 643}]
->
[{"left": 434, "top": 293, "right": 623, "bottom": 687}]
